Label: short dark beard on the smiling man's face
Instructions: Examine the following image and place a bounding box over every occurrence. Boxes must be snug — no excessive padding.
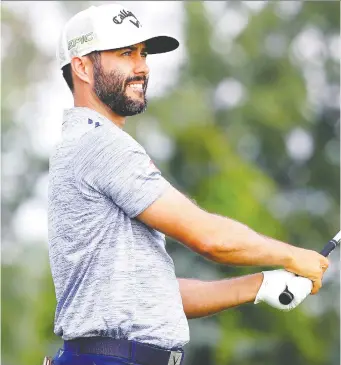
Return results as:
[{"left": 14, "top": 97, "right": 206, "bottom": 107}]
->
[{"left": 93, "top": 62, "right": 148, "bottom": 117}]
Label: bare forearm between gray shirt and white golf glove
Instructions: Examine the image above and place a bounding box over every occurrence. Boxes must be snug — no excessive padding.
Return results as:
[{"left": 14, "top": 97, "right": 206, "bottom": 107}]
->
[{"left": 178, "top": 273, "right": 263, "bottom": 319}]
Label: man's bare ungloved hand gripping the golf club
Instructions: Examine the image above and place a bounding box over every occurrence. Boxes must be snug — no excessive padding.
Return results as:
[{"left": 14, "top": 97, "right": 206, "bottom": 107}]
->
[{"left": 285, "top": 247, "right": 329, "bottom": 294}]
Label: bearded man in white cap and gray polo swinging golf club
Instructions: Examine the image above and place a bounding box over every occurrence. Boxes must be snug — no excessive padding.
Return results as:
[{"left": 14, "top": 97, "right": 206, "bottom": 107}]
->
[{"left": 49, "top": 4, "right": 328, "bottom": 365}]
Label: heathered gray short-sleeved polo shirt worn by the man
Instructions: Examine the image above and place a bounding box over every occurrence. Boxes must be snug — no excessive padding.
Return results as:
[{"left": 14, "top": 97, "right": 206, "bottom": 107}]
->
[{"left": 48, "top": 107, "right": 189, "bottom": 349}]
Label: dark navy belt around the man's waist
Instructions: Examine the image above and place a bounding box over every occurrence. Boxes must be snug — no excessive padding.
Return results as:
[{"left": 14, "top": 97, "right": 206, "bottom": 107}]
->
[{"left": 64, "top": 337, "right": 184, "bottom": 365}]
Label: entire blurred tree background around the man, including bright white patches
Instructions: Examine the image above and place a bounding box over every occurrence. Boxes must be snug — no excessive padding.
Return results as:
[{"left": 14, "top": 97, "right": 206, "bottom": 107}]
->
[{"left": 1, "top": 1, "right": 340, "bottom": 365}]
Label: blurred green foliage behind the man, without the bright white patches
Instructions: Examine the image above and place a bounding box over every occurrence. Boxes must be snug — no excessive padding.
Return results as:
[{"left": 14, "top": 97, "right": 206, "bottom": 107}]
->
[{"left": 1, "top": 1, "right": 340, "bottom": 365}]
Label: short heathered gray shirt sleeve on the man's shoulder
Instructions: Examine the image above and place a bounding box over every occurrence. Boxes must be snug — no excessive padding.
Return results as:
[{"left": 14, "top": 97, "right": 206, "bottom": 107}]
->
[{"left": 74, "top": 127, "right": 170, "bottom": 218}]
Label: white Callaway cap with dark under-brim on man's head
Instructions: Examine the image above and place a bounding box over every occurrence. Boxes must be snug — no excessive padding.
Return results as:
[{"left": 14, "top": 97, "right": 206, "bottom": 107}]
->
[{"left": 57, "top": 4, "right": 179, "bottom": 68}]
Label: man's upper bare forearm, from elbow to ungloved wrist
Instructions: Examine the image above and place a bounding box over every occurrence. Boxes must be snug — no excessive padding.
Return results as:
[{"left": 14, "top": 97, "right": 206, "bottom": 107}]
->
[{"left": 204, "top": 215, "right": 294, "bottom": 267}]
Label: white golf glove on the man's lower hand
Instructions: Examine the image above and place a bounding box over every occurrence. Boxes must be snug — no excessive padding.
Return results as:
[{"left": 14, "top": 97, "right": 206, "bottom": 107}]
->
[{"left": 254, "top": 270, "right": 313, "bottom": 311}]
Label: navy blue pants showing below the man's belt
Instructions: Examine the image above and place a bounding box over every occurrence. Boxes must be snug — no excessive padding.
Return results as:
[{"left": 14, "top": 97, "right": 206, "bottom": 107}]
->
[{"left": 52, "top": 349, "right": 133, "bottom": 365}]
